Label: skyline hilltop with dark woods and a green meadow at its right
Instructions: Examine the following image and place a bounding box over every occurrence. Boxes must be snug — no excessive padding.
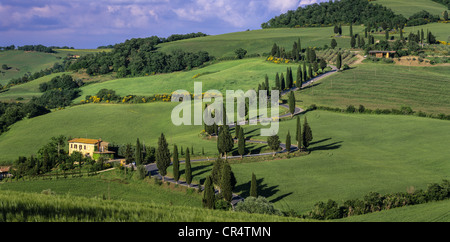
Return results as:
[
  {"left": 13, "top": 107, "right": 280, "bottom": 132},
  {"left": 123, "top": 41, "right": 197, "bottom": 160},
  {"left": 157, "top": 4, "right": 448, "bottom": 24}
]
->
[{"left": 261, "top": 0, "right": 445, "bottom": 29}]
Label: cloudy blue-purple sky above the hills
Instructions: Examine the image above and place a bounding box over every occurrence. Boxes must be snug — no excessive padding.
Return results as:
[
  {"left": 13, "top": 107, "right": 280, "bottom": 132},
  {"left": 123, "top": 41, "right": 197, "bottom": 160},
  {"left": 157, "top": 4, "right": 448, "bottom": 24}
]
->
[{"left": 0, "top": 0, "right": 324, "bottom": 49}]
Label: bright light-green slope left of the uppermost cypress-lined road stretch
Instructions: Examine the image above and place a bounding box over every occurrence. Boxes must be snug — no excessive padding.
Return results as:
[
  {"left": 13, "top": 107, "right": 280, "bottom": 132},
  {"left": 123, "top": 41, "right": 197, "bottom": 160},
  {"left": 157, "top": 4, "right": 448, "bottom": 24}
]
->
[{"left": 74, "top": 58, "right": 298, "bottom": 103}]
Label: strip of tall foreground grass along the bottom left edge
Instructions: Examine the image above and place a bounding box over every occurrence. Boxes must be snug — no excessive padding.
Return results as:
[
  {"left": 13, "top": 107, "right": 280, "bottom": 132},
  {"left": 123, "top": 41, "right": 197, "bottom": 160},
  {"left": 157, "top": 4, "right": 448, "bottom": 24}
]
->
[{"left": 0, "top": 192, "right": 305, "bottom": 222}]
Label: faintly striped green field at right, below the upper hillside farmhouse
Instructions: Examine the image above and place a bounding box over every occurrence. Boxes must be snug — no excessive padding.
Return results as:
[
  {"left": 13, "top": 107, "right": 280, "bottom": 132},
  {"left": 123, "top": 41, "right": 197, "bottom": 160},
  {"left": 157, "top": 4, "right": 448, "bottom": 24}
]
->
[{"left": 290, "top": 63, "right": 450, "bottom": 114}]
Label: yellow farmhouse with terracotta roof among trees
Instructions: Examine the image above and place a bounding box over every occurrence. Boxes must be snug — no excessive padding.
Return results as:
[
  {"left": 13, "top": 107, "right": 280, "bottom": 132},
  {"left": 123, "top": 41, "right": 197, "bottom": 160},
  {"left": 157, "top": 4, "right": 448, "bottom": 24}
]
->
[{"left": 69, "top": 139, "right": 114, "bottom": 160}]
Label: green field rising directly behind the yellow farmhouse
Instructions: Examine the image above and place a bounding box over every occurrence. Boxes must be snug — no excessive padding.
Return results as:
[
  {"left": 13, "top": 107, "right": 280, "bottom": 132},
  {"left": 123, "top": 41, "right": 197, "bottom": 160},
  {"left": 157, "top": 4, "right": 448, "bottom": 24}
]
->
[{"left": 0, "top": 103, "right": 272, "bottom": 162}]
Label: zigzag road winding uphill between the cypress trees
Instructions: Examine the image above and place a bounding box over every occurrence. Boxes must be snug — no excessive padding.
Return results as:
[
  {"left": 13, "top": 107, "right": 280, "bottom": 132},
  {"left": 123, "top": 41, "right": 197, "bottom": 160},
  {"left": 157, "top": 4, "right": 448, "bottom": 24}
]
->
[{"left": 146, "top": 65, "right": 337, "bottom": 207}]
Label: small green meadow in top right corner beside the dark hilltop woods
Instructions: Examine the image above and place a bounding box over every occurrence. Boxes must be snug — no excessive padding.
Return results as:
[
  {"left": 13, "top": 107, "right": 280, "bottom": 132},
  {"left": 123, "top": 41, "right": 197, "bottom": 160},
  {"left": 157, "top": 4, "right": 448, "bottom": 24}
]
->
[{"left": 374, "top": 0, "right": 447, "bottom": 18}]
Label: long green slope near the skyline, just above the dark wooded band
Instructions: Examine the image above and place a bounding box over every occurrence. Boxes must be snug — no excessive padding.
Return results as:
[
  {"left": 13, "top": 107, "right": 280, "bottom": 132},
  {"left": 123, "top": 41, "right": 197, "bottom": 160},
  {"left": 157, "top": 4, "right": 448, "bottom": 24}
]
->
[{"left": 156, "top": 26, "right": 364, "bottom": 57}]
